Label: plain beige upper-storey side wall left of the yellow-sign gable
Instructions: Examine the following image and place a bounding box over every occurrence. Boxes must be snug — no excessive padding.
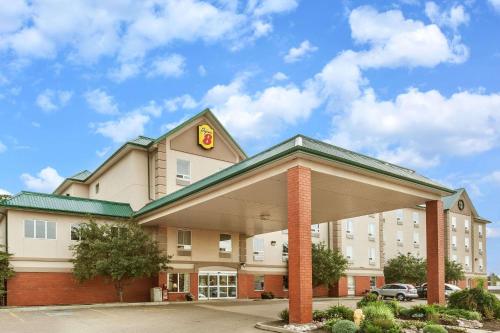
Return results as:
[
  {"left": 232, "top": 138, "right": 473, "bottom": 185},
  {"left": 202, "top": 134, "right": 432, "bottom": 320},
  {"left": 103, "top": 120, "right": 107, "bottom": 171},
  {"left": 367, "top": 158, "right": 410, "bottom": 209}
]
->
[{"left": 89, "top": 150, "right": 148, "bottom": 210}]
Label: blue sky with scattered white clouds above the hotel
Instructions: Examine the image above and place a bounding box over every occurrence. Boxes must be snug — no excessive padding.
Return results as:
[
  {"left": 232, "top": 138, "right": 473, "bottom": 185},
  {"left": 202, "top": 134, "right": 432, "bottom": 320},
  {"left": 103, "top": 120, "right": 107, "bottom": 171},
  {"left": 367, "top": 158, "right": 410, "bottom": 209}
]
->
[{"left": 0, "top": 0, "right": 500, "bottom": 273}]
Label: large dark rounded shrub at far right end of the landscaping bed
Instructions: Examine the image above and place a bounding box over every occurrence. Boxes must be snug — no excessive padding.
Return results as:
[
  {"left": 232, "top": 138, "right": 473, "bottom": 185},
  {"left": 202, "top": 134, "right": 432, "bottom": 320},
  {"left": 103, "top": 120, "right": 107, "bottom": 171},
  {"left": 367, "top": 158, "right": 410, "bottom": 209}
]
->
[{"left": 448, "top": 287, "right": 500, "bottom": 319}]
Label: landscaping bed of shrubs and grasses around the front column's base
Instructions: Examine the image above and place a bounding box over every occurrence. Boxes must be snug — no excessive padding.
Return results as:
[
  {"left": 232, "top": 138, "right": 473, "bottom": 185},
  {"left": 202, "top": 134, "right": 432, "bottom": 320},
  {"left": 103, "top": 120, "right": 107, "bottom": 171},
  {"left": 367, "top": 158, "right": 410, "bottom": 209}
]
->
[{"left": 274, "top": 288, "right": 500, "bottom": 333}]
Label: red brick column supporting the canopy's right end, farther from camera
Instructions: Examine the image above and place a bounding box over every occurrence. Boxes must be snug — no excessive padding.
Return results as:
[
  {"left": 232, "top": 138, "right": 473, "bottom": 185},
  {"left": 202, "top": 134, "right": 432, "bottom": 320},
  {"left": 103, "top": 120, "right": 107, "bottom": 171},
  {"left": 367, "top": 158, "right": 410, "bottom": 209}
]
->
[{"left": 426, "top": 200, "right": 446, "bottom": 304}]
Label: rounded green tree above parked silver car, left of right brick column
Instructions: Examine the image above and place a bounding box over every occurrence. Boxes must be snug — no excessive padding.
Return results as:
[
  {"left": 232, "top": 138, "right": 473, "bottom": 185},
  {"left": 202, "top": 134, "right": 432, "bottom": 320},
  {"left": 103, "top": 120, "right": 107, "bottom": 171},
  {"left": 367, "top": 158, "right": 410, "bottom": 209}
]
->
[{"left": 384, "top": 253, "right": 427, "bottom": 285}]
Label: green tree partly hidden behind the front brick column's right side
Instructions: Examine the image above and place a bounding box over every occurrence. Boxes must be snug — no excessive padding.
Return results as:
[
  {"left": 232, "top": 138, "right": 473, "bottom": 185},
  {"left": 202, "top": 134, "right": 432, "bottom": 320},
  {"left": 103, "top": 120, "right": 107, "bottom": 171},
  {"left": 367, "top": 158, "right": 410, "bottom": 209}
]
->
[{"left": 312, "top": 243, "right": 349, "bottom": 287}]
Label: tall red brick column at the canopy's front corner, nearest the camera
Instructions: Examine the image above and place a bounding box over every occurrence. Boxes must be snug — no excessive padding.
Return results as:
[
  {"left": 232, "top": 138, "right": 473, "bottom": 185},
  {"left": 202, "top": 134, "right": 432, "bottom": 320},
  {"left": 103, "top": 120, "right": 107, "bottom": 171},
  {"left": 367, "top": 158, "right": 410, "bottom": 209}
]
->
[{"left": 287, "top": 166, "right": 312, "bottom": 324}]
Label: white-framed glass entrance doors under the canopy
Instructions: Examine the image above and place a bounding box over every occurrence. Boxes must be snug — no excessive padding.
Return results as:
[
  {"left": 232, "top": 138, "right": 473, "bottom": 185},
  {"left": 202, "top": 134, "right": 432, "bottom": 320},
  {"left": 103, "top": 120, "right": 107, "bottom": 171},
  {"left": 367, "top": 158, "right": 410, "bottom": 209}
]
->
[{"left": 198, "top": 272, "right": 238, "bottom": 299}]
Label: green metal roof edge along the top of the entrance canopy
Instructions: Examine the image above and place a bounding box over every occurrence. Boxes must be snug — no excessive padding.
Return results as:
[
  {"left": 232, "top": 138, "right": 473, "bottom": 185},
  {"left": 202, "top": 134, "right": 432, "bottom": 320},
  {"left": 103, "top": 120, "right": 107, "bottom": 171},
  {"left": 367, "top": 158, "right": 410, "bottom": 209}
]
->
[{"left": 134, "top": 135, "right": 453, "bottom": 216}]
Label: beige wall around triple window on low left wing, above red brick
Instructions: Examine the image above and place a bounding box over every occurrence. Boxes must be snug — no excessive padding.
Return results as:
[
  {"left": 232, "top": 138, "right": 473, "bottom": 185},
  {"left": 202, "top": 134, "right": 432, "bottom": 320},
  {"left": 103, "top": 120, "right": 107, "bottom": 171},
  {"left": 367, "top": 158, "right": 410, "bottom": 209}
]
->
[{"left": 8, "top": 210, "right": 124, "bottom": 271}]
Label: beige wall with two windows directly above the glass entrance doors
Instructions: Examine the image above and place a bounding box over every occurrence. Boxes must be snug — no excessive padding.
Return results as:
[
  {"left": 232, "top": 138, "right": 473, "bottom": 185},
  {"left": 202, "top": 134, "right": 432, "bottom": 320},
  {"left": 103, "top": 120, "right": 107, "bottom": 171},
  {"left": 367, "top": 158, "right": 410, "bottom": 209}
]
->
[{"left": 165, "top": 227, "right": 239, "bottom": 263}]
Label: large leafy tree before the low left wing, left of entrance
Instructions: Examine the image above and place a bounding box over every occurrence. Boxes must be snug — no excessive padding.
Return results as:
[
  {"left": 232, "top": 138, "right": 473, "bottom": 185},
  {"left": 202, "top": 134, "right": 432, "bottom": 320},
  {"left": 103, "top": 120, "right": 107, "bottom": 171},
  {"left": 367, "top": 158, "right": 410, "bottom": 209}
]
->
[{"left": 71, "top": 220, "right": 169, "bottom": 302}]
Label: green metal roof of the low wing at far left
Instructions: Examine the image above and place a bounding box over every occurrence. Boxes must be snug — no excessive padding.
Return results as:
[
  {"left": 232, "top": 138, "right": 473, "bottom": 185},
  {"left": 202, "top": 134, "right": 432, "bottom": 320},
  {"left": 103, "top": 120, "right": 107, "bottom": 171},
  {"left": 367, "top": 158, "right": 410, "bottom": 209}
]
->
[{"left": 0, "top": 191, "right": 133, "bottom": 218}]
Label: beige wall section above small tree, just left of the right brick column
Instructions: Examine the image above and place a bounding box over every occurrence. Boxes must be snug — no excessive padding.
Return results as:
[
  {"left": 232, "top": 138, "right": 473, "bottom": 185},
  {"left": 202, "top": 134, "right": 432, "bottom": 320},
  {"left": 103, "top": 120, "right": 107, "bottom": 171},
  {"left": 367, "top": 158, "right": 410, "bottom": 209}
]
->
[{"left": 382, "top": 208, "right": 427, "bottom": 262}]
